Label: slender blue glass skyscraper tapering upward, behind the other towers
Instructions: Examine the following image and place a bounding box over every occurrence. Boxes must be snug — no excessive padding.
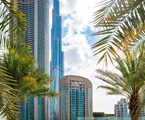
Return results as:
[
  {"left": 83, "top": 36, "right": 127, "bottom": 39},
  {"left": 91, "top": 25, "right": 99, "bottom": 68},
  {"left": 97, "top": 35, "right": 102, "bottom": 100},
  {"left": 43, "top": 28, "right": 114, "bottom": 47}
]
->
[{"left": 50, "top": 0, "right": 64, "bottom": 120}]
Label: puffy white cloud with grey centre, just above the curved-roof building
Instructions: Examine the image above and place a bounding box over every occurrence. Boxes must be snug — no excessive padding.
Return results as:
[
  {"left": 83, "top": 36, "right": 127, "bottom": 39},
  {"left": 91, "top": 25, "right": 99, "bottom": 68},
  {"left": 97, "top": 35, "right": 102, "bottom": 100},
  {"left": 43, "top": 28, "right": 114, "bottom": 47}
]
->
[{"left": 63, "top": 33, "right": 91, "bottom": 69}]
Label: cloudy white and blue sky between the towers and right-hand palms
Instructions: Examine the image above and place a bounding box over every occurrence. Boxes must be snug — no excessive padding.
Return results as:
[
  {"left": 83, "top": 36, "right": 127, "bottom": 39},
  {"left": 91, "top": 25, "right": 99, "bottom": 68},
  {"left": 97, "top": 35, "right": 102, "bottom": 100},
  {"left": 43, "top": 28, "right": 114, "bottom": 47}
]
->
[{"left": 50, "top": 0, "right": 124, "bottom": 113}]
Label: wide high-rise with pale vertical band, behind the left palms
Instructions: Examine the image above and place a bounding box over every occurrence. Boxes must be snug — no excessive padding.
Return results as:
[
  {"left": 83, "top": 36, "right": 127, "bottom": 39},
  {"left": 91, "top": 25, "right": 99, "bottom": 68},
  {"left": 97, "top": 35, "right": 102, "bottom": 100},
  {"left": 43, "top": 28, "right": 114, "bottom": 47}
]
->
[{"left": 17, "top": 0, "right": 49, "bottom": 120}]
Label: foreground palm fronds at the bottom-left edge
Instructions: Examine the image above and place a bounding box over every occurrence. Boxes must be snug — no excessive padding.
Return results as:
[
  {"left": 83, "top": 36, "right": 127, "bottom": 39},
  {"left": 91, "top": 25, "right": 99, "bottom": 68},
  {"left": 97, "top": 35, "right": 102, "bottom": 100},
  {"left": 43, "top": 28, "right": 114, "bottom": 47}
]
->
[{"left": 0, "top": 65, "right": 18, "bottom": 120}]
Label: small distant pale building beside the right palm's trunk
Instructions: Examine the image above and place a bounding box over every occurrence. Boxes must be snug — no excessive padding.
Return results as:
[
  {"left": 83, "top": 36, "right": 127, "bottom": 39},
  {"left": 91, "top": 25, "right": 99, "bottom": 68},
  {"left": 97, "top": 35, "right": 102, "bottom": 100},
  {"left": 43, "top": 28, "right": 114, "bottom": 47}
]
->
[{"left": 114, "top": 98, "right": 129, "bottom": 120}]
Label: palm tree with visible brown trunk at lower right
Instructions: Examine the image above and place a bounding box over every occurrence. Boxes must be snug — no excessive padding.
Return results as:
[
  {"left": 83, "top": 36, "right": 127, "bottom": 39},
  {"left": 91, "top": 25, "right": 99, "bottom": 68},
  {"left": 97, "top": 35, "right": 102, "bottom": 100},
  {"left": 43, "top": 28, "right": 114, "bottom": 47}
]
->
[{"left": 97, "top": 54, "right": 145, "bottom": 120}]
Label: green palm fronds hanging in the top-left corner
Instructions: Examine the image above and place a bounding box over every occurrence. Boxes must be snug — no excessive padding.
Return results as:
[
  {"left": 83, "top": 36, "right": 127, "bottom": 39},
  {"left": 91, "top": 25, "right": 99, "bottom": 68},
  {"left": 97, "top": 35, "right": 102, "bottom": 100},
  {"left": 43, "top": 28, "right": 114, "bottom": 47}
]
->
[{"left": 0, "top": 0, "right": 26, "bottom": 43}]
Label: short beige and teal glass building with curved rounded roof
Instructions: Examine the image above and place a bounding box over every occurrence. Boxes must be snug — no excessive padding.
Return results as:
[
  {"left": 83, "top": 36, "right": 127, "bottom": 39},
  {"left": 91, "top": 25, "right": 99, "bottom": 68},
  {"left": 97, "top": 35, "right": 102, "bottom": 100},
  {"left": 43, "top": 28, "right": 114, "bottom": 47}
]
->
[{"left": 59, "top": 75, "right": 93, "bottom": 120}]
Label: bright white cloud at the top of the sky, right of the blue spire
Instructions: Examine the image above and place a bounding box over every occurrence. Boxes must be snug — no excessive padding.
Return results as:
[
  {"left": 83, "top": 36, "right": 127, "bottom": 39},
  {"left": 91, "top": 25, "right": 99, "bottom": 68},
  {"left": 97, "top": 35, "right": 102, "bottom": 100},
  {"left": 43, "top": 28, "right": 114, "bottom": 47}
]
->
[{"left": 60, "top": 0, "right": 96, "bottom": 32}]
